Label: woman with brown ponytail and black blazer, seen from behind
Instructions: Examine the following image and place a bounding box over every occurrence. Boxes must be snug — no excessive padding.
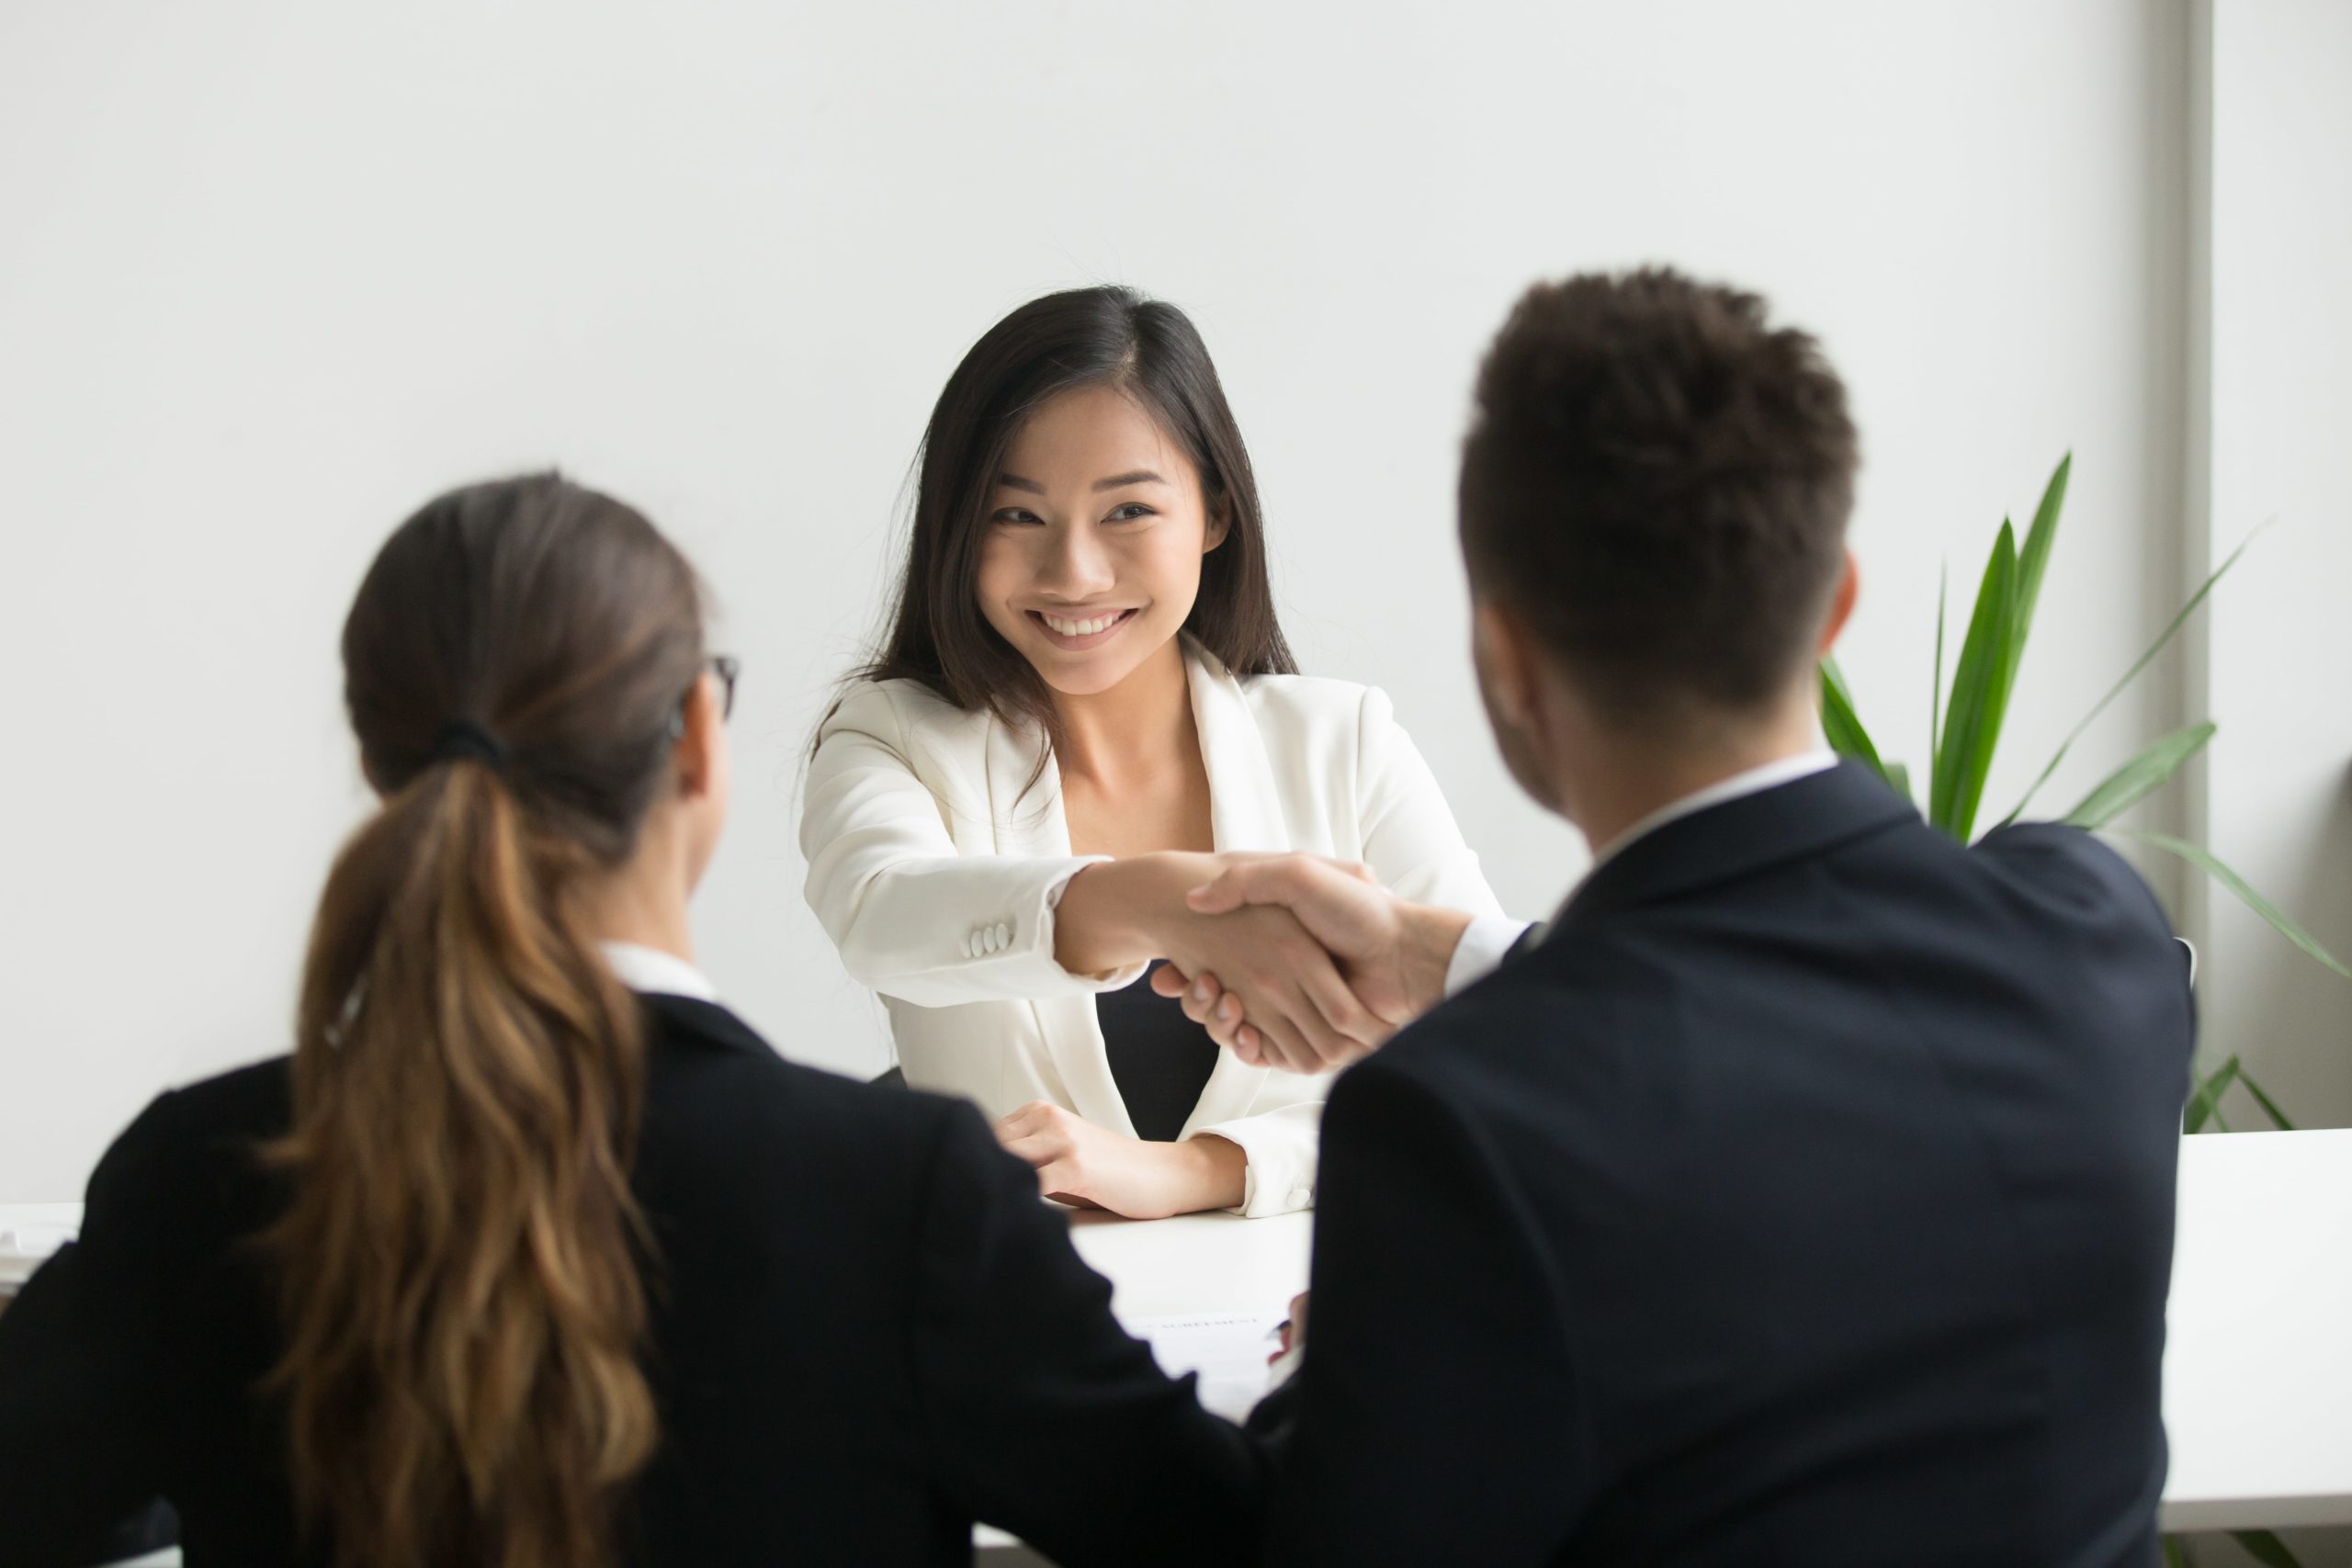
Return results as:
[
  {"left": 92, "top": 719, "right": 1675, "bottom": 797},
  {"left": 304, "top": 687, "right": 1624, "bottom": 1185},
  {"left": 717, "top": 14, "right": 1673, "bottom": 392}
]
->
[{"left": 0, "top": 475, "right": 1256, "bottom": 1568}]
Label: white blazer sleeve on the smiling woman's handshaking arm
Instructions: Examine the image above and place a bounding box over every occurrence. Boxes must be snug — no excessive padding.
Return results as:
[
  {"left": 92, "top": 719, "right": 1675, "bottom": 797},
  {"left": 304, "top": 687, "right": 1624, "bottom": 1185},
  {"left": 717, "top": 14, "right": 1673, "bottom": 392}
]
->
[{"left": 799, "top": 682, "right": 1143, "bottom": 1006}]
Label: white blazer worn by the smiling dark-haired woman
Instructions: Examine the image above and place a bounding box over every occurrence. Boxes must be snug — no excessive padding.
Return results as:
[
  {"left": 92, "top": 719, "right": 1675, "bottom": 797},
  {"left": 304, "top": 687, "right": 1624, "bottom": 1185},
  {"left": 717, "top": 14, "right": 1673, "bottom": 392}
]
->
[{"left": 799, "top": 637, "right": 1500, "bottom": 1215}]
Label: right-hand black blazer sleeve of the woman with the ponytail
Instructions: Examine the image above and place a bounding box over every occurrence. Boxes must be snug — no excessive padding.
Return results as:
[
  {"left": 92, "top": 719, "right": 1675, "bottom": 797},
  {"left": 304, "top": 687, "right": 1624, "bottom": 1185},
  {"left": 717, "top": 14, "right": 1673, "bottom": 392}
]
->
[{"left": 915, "top": 1105, "right": 1263, "bottom": 1568}]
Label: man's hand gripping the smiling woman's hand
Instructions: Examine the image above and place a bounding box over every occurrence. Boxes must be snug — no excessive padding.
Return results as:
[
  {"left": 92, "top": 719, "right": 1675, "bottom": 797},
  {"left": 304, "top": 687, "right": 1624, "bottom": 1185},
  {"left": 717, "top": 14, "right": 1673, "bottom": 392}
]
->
[{"left": 1152, "top": 856, "right": 1470, "bottom": 1072}]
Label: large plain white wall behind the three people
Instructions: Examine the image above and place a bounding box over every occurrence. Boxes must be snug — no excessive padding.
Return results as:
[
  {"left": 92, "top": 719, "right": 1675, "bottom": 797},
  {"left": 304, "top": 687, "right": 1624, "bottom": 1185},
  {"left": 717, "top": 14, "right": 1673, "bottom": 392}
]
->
[{"left": 0, "top": 0, "right": 2201, "bottom": 1201}]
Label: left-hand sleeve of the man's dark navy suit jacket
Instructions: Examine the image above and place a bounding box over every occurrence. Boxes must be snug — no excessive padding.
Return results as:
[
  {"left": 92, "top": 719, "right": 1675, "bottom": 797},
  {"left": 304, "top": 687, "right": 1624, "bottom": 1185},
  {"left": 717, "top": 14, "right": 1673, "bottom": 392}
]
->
[{"left": 1251, "top": 1058, "right": 1595, "bottom": 1568}]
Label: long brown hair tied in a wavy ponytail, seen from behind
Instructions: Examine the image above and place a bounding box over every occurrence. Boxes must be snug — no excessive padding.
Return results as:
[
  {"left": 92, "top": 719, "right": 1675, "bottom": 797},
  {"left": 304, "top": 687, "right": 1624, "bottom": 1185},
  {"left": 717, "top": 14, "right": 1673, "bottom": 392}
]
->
[{"left": 264, "top": 475, "right": 703, "bottom": 1568}]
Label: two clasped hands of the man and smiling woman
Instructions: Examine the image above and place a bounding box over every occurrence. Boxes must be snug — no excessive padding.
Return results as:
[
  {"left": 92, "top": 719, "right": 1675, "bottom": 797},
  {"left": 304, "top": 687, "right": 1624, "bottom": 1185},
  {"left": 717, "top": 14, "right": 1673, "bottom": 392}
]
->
[{"left": 1152, "top": 856, "right": 1470, "bottom": 1072}]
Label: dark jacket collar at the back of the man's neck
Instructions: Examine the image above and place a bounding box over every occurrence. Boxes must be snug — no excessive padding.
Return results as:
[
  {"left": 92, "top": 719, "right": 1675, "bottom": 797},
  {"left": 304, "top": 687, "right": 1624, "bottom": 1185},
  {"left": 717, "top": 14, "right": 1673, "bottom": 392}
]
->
[{"left": 1555, "top": 761, "right": 1919, "bottom": 929}]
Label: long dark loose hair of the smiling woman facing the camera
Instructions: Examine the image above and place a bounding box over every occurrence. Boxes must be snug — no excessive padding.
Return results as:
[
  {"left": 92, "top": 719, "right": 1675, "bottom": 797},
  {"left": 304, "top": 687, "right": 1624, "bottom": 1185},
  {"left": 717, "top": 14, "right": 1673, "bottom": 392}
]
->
[{"left": 852, "top": 287, "right": 1298, "bottom": 740}]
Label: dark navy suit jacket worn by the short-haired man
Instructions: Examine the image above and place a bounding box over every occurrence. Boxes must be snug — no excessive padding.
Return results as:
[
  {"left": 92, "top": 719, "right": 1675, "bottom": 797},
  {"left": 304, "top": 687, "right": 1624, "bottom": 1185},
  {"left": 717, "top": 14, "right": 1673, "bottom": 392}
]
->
[{"left": 1253, "top": 766, "right": 2194, "bottom": 1568}]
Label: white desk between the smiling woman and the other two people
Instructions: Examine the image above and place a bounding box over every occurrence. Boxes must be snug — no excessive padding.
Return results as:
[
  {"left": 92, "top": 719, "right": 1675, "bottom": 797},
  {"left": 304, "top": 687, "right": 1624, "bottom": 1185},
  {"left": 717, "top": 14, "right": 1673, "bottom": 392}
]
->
[{"left": 0, "top": 1131, "right": 2352, "bottom": 1541}]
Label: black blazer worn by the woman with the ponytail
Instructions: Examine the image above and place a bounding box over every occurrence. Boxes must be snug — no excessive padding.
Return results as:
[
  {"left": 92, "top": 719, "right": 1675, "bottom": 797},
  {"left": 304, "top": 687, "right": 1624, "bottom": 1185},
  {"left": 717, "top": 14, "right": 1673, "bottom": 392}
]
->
[{"left": 0, "top": 997, "right": 1261, "bottom": 1568}]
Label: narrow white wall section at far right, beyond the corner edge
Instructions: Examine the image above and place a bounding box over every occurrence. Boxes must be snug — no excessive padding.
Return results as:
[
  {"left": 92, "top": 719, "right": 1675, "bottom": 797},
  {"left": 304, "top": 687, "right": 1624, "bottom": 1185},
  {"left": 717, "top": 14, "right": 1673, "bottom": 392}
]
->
[{"left": 2189, "top": 0, "right": 2352, "bottom": 1128}]
